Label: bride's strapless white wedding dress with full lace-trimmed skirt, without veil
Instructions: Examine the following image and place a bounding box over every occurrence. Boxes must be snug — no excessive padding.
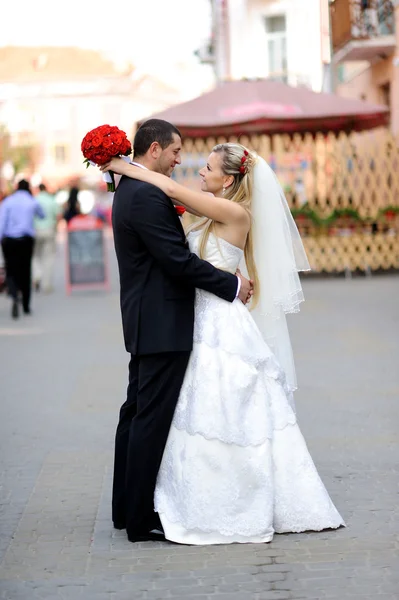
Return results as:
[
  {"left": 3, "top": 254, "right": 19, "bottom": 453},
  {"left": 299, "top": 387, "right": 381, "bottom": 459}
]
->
[{"left": 155, "top": 232, "right": 344, "bottom": 545}]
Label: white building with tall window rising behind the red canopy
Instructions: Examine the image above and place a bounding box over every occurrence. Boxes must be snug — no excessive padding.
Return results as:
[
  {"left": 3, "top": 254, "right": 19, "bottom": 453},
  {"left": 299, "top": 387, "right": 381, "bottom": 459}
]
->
[{"left": 200, "top": 0, "right": 330, "bottom": 91}]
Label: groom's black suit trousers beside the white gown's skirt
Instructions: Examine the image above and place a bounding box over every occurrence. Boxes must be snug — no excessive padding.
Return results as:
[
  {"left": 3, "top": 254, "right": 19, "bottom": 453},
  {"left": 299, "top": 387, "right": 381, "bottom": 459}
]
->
[{"left": 112, "top": 352, "right": 190, "bottom": 537}]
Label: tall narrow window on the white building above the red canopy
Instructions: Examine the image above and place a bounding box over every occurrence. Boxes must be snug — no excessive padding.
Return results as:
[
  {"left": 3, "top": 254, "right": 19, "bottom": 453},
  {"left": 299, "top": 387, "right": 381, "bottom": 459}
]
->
[{"left": 265, "top": 15, "right": 287, "bottom": 82}]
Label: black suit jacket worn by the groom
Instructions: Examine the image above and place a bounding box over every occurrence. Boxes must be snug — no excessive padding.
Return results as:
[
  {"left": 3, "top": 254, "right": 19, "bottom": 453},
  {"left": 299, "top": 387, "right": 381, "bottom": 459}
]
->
[{"left": 112, "top": 177, "right": 237, "bottom": 355}]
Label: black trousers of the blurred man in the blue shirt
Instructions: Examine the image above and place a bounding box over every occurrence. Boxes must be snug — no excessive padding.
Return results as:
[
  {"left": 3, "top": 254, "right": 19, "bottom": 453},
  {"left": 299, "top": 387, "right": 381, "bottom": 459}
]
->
[{"left": 1, "top": 235, "right": 35, "bottom": 310}]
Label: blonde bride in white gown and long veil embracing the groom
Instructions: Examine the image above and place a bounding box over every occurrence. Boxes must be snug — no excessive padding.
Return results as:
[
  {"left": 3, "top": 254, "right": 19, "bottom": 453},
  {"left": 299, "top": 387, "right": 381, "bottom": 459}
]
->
[{"left": 102, "top": 143, "right": 345, "bottom": 545}]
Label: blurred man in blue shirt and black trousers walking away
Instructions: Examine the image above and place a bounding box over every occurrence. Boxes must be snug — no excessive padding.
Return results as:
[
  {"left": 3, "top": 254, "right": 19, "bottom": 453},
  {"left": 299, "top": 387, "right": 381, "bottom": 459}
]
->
[{"left": 0, "top": 179, "right": 45, "bottom": 319}]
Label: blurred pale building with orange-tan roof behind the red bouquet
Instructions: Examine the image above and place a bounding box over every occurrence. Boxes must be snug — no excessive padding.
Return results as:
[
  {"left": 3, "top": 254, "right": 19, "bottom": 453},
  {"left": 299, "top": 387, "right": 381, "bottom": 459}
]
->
[{"left": 0, "top": 47, "right": 195, "bottom": 185}]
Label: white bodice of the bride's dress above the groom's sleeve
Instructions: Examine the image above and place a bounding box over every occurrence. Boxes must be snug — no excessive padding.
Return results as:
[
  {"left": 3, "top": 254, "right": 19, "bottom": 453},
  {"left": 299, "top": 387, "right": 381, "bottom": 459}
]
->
[{"left": 187, "top": 230, "right": 244, "bottom": 273}]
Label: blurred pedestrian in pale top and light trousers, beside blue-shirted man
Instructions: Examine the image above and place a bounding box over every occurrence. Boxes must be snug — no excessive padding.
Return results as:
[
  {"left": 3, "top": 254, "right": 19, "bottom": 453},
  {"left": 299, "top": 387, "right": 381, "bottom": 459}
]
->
[{"left": 33, "top": 183, "right": 60, "bottom": 293}]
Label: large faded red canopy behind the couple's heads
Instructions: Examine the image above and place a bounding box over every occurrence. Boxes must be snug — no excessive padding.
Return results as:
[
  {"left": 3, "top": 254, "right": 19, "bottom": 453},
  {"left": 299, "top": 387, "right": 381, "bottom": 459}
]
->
[{"left": 139, "top": 79, "right": 389, "bottom": 138}]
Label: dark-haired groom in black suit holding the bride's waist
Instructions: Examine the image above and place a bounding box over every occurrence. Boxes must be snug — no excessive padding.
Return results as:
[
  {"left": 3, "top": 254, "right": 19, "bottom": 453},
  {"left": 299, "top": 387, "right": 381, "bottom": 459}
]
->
[{"left": 112, "top": 119, "right": 251, "bottom": 542}]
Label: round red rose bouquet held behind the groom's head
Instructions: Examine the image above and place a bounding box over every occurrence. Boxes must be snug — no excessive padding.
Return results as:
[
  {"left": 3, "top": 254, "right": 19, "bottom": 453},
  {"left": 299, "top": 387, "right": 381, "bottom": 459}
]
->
[{"left": 81, "top": 125, "right": 132, "bottom": 192}]
